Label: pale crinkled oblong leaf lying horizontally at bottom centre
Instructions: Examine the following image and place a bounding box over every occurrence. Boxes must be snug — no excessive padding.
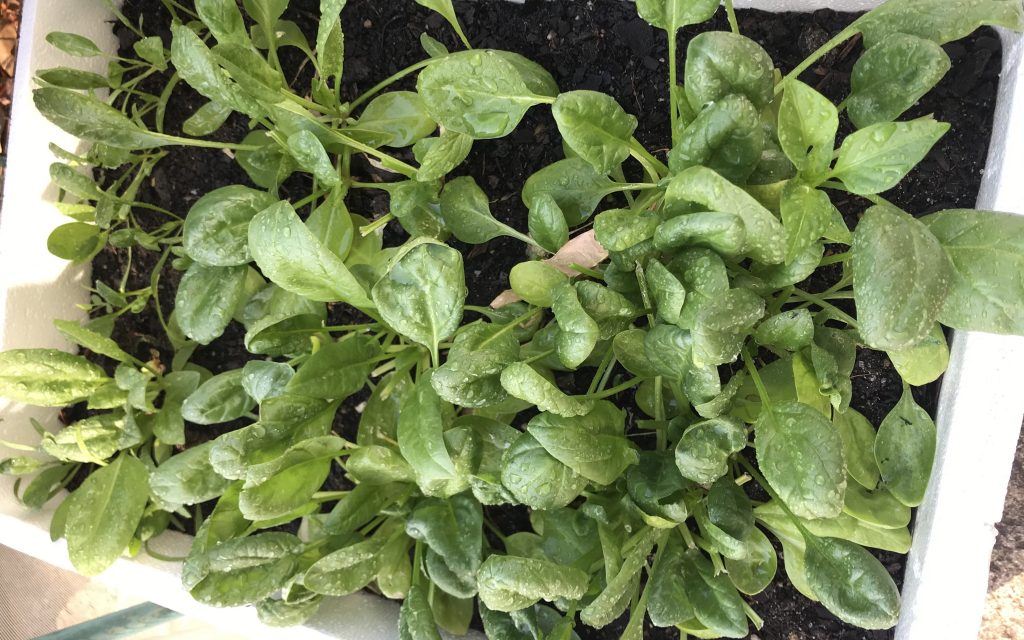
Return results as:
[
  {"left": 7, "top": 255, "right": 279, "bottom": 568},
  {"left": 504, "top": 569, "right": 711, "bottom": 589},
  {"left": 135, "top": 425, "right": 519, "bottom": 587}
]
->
[{"left": 476, "top": 554, "right": 589, "bottom": 611}]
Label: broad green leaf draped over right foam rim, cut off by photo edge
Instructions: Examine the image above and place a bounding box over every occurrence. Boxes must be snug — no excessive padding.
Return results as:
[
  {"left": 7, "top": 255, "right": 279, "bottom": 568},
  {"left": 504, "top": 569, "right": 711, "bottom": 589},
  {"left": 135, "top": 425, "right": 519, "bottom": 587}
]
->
[{"left": 925, "top": 209, "right": 1024, "bottom": 333}]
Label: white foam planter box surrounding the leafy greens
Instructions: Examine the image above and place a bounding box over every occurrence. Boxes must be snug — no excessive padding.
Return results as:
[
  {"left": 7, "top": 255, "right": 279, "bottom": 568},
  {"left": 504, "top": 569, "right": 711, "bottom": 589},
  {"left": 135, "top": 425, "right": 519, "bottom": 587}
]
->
[{"left": 0, "top": 0, "right": 1024, "bottom": 640}]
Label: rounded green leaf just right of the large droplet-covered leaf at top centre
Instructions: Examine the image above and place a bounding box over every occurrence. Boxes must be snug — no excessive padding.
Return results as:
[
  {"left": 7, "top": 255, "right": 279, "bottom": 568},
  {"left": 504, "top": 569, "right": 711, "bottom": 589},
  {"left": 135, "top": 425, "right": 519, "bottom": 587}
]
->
[{"left": 551, "top": 91, "right": 637, "bottom": 173}]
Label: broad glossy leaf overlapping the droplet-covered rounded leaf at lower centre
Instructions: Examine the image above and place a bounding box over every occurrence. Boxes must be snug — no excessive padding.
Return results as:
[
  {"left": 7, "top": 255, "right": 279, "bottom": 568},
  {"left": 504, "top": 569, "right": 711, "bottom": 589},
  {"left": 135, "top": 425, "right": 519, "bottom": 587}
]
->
[{"left": 526, "top": 400, "right": 637, "bottom": 484}]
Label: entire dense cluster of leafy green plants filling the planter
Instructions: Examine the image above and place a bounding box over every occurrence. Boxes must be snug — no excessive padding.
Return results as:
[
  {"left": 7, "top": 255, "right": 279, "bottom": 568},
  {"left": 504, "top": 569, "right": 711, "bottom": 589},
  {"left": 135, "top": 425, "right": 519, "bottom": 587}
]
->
[{"left": 0, "top": 0, "right": 1024, "bottom": 638}]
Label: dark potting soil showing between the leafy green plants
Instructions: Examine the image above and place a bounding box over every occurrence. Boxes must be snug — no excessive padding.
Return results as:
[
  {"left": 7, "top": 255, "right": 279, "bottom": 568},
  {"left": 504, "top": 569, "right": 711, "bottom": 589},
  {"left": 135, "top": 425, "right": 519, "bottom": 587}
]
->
[{"left": 70, "top": 0, "right": 1001, "bottom": 640}]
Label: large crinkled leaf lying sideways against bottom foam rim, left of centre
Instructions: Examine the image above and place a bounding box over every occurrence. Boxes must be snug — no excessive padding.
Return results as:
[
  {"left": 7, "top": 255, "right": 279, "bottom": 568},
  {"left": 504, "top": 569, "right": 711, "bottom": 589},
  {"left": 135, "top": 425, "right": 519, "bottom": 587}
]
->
[{"left": 189, "top": 532, "right": 302, "bottom": 606}]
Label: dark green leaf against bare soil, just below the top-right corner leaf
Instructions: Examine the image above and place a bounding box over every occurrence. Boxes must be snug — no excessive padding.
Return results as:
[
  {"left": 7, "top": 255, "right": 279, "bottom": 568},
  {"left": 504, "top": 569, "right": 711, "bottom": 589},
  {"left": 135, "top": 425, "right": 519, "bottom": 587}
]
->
[{"left": 846, "top": 33, "right": 950, "bottom": 128}]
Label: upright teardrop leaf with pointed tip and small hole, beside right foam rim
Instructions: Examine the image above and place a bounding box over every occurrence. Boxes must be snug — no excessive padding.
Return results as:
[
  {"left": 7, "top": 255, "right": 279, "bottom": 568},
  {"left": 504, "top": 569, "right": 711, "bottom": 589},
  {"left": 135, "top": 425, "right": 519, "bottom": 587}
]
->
[{"left": 874, "top": 387, "right": 936, "bottom": 507}]
